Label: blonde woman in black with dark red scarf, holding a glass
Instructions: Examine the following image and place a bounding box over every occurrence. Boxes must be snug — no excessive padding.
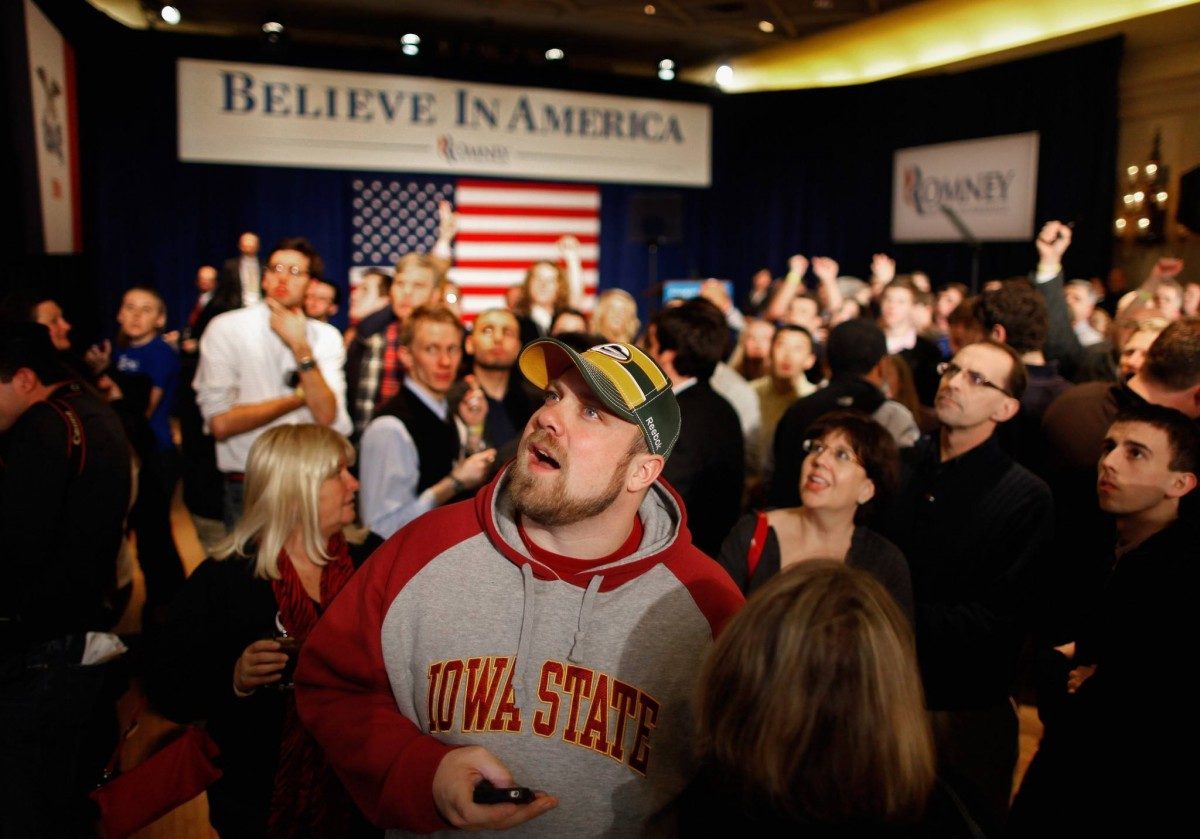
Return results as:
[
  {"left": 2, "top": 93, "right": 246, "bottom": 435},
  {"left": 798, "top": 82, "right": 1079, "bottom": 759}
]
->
[{"left": 150, "top": 425, "right": 358, "bottom": 837}]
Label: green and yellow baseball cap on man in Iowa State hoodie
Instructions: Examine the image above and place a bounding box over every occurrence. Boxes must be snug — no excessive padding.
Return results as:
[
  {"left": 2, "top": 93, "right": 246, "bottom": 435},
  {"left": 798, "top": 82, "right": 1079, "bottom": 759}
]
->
[{"left": 518, "top": 338, "right": 679, "bottom": 457}]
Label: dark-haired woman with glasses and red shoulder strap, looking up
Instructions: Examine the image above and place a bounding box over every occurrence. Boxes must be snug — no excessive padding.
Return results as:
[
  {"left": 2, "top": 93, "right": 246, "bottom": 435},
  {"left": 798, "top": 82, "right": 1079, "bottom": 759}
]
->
[{"left": 719, "top": 410, "right": 913, "bottom": 618}]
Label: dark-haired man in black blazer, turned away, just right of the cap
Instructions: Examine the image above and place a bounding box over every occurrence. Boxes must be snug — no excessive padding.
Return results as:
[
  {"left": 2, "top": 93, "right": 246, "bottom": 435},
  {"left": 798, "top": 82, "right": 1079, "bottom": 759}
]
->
[{"left": 647, "top": 298, "right": 745, "bottom": 557}]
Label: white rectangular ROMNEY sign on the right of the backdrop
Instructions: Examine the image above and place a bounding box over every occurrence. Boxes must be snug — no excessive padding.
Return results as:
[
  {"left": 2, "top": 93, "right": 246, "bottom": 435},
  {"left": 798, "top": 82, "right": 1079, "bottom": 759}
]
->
[{"left": 892, "top": 131, "right": 1038, "bottom": 241}]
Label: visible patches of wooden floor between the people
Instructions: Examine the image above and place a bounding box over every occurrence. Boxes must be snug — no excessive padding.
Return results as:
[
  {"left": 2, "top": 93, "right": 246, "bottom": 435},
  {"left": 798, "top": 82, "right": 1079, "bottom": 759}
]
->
[{"left": 116, "top": 493, "right": 1042, "bottom": 839}]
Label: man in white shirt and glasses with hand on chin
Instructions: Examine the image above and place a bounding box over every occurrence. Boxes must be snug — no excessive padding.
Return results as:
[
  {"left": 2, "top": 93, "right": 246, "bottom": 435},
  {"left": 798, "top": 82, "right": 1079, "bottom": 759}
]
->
[{"left": 193, "top": 236, "right": 350, "bottom": 527}]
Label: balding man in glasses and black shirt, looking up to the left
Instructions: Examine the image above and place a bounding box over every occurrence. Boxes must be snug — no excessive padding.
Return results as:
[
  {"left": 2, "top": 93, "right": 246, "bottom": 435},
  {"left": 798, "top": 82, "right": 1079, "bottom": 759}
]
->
[{"left": 883, "top": 341, "right": 1054, "bottom": 828}]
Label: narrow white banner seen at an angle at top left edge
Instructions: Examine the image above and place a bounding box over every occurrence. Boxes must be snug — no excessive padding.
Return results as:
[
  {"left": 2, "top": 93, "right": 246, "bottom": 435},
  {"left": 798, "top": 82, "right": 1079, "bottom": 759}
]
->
[{"left": 25, "top": 0, "right": 82, "bottom": 253}]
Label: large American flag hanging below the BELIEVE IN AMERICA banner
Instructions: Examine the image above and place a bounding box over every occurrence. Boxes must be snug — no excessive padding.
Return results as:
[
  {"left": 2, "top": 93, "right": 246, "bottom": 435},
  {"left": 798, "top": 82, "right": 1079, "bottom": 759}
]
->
[{"left": 352, "top": 179, "right": 600, "bottom": 320}]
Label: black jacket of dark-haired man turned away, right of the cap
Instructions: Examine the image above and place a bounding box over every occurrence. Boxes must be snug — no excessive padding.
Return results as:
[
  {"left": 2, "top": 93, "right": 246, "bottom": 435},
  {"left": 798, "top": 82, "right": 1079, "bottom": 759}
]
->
[{"left": 662, "top": 380, "right": 745, "bottom": 557}]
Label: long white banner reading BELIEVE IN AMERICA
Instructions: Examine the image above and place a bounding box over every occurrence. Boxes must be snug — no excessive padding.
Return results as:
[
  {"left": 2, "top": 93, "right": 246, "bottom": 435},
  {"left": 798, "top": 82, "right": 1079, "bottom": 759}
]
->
[{"left": 178, "top": 59, "right": 712, "bottom": 186}]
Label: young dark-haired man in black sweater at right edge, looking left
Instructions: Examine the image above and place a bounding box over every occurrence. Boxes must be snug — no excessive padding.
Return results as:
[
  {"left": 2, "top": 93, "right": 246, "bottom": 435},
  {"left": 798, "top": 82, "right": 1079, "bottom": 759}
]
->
[{"left": 1013, "top": 403, "right": 1200, "bottom": 834}]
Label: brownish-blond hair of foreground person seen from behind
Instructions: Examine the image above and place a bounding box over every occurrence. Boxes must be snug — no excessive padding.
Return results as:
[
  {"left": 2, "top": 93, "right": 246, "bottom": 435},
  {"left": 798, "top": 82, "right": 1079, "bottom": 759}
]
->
[{"left": 698, "top": 561, "right": 935, "bottom": 823}]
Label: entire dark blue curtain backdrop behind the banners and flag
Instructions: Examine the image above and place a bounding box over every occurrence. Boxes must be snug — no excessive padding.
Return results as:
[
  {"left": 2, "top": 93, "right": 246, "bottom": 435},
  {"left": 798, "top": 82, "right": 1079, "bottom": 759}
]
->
[{"left": 25, "top": 0, "right": 1121, "bottom": 338}]
